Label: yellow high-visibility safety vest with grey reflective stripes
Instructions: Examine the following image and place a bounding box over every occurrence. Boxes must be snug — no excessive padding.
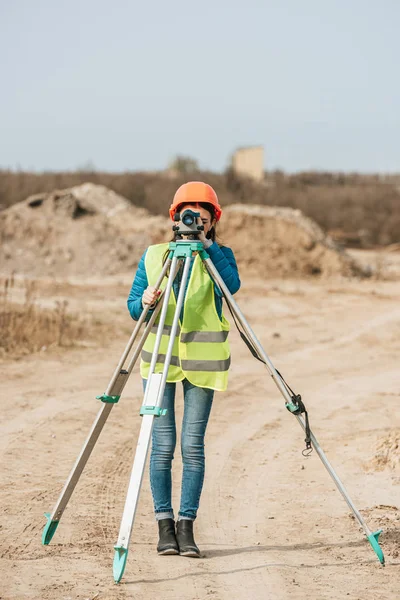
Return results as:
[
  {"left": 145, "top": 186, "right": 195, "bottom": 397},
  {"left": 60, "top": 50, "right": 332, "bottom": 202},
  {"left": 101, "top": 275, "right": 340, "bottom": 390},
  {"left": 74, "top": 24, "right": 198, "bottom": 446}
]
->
[{"left": 140, "top": 243, "right": 231, "bottom": 392}]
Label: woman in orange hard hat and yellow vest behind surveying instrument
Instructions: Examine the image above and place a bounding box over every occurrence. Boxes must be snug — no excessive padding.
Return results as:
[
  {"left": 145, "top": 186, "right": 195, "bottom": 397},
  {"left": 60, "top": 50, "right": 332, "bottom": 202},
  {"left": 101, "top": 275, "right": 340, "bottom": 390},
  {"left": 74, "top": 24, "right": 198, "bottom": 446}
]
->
[{"left": 128, "top": 181, "right": 240, "bottom": 557}]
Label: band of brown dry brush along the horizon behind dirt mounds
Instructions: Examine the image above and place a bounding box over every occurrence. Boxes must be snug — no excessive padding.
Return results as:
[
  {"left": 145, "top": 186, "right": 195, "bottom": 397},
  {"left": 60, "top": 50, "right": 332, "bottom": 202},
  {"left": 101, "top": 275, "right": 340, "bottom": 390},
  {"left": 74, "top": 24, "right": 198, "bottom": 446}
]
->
[{"left": 0, "top": 170, "right": 400, "bottom": 247}]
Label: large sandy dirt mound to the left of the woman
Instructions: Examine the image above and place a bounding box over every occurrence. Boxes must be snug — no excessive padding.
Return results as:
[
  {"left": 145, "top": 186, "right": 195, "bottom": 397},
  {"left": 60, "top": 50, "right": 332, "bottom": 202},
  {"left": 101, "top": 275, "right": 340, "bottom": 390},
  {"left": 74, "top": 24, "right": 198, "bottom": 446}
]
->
[{"left": 0, "top": 183, "right": 166, "bottom": 276}]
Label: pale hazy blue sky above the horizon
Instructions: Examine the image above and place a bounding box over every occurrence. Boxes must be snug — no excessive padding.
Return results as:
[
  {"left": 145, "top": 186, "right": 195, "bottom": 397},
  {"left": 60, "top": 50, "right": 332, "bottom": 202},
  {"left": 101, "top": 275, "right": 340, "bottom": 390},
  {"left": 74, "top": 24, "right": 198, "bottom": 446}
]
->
[{"left": 0, "top": 0, "right": 400, "bottom": 172}]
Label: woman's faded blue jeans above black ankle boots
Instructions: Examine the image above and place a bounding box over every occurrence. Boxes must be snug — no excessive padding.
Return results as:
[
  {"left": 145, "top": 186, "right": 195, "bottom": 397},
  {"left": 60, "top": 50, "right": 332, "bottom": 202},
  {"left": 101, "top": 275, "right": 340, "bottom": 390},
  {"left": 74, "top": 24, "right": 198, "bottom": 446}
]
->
[{"left": 144, "top": 379, "right": 214, "bottom": 521}]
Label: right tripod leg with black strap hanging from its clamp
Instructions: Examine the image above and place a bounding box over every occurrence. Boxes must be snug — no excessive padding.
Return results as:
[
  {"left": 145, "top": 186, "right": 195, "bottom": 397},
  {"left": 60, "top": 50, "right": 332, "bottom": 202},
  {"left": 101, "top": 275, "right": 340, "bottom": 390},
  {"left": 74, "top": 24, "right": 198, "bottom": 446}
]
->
[{"left": 203, "top": 255, "right": 385, "bottom": 565}]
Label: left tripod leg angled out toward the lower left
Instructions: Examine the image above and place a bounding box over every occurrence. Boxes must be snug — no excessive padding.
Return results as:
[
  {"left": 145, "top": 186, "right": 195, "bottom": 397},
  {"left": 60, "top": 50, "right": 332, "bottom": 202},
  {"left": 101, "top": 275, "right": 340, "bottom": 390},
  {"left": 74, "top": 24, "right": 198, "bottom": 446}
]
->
[{"left": 42, "top": 259, "right": 171, "bottom": 546}]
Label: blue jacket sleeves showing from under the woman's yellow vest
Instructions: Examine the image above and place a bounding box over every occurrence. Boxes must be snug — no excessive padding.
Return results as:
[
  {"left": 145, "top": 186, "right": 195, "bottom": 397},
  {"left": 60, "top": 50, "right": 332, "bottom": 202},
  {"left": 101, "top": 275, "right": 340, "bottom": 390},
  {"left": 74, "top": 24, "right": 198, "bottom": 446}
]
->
[{"left": 128, "top": 242, "right": 240, "bottom": 322}]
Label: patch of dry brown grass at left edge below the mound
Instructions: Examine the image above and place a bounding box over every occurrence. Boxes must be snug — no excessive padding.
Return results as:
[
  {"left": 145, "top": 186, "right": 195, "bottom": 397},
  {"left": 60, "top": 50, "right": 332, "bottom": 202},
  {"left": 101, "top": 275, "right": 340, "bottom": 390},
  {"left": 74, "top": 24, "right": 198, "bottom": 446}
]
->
[{"left": 0, "top": 277, "right": 90, "bottom": 356}]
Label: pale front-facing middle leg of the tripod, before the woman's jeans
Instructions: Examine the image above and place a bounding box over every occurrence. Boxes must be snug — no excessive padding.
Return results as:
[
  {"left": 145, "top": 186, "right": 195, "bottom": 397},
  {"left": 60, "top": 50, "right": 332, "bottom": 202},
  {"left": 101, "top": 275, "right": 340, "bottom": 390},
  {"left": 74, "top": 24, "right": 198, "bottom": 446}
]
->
[{"left": 113, "top": 253, "right": 190, "bottom": 583}]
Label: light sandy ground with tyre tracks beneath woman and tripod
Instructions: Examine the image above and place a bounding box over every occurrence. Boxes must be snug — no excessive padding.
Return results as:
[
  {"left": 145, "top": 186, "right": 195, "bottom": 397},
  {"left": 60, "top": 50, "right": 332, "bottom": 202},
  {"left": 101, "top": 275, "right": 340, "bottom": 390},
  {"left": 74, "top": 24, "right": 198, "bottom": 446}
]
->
[{"left": 0, "top": 268, "right": 400, "bottom": 600}]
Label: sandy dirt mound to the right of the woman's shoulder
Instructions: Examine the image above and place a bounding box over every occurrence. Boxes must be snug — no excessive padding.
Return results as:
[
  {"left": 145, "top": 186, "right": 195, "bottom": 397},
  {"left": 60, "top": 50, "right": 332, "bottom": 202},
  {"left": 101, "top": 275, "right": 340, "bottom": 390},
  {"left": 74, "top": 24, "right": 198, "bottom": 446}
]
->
[{"left": 221, "top": 204, "right": 371, "bottom": 277}]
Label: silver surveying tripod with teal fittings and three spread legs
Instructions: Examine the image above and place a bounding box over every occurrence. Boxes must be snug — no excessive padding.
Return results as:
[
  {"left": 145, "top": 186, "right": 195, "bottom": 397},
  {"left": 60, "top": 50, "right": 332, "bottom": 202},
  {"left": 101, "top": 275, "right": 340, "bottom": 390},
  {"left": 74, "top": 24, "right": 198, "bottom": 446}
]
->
[{"left": 42, "top": 239, "right": 385, "bottom": 583}]
